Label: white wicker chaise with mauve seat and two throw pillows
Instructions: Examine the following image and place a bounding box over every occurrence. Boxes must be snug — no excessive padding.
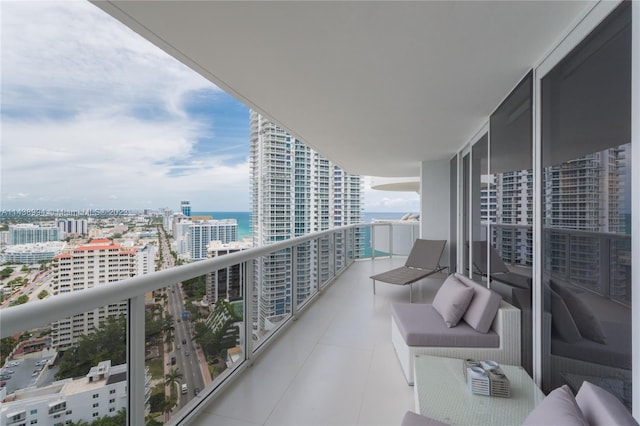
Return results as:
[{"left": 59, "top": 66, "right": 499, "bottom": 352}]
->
[{"left": 391, "top": 274, "right": 521, "bottom": 385}]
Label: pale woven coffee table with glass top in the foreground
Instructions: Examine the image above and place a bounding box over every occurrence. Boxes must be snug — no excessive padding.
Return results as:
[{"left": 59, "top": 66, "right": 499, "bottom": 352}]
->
[{"left": 414, "top": 355, "right": 544, "bottom": 426}]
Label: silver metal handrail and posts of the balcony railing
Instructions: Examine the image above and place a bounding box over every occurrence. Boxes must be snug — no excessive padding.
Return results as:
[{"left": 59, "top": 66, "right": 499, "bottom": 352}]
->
[{"left": 0, "top": 224, "right": 396, "bottom": 425}]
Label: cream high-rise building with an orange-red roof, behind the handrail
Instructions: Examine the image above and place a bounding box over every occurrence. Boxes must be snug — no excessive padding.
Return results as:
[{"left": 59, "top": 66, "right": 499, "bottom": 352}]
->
[{"left": 51, "top": 239, "right": 154, "bottom": 350}]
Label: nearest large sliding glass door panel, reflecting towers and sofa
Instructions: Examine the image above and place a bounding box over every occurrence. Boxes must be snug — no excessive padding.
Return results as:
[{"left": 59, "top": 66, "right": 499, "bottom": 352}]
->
[{"left": 541, "top": 2, "right": 632, "bottom": 408}]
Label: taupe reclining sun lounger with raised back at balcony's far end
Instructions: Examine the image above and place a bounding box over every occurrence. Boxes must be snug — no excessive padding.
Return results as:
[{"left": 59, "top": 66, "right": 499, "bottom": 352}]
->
[{"left": 371, "top": 239, "right": 447, "bottom": 302}]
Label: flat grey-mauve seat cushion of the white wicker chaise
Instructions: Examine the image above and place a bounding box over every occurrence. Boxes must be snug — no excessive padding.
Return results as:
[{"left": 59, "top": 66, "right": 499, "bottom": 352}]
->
[{"left": 391, "top": 303, "right": 500, "bottom": 348}]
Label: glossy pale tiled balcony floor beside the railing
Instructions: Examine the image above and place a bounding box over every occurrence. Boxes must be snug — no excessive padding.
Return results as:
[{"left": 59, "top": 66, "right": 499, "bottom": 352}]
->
[{"left": 191, "top": 257, "right": 445, "bottom": 426}]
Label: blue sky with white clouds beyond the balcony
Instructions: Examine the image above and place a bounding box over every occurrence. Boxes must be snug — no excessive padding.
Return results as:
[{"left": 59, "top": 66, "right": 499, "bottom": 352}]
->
[{"left": 0, "top": 0, "right": 419, "bottom": 212}]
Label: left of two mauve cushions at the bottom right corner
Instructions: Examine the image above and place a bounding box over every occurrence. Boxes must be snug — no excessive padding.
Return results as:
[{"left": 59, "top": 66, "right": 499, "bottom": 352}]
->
[{"left": 522, "top": 385, "right": 589, "bottom": 426}]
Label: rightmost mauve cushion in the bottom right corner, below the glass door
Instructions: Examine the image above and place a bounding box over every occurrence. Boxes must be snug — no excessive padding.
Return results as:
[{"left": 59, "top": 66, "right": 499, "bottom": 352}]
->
[{"left": 576, "top": 381, "right": 638, "bottom": 426}]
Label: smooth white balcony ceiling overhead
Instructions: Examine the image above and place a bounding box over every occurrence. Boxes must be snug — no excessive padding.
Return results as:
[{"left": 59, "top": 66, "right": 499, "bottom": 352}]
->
[{"left": 94, "top": 0, "right": 593, "bottom": 176}]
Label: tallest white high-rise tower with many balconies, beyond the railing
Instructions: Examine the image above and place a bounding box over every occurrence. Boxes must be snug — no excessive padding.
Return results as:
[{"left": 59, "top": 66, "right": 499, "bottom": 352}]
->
[{"left": 250, "top": 111, "right": 363, "bottom": 329}]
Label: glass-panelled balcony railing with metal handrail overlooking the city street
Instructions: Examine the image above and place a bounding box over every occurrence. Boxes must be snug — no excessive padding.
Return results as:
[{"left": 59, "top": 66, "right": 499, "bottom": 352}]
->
[{"left": 0, "top": 224, "right": 400, "bottom": 425}]
